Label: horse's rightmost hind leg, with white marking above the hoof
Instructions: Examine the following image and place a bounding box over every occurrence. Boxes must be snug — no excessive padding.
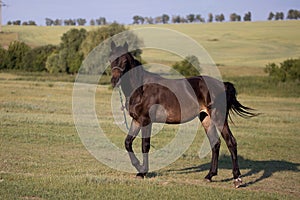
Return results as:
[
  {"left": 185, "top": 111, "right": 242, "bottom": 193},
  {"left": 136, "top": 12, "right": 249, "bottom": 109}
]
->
[{"left": 221, "top": 121, "right": 242, "bottom": 188}]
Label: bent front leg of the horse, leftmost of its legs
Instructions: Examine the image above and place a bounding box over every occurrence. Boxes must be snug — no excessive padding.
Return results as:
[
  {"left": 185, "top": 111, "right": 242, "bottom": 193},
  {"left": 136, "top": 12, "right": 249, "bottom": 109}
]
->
[{"left": 125, "top": 120, "right": 142, "bottom": 172}]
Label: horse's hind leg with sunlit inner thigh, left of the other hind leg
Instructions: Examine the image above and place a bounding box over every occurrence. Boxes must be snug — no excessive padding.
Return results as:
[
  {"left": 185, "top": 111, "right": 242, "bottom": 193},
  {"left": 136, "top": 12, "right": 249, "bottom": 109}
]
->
[{"left": 199, "top": 111, "right": 221, "bottom": 181}]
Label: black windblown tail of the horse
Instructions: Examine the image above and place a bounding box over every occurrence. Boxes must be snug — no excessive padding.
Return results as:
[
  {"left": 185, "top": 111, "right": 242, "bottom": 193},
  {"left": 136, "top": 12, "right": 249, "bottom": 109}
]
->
[{"left": 224, "top": 82, "right": 258, "bottom": 121}]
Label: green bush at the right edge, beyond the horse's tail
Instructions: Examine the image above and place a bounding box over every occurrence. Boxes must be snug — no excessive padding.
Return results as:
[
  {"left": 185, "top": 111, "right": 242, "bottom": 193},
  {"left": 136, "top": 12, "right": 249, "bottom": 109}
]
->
[{"left": 265, "top": 58, "right": 300, "bottom": 82}]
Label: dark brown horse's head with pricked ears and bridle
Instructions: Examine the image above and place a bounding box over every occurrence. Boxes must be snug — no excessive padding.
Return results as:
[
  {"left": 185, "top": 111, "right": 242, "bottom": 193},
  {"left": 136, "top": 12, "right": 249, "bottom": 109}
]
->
[{"left": 109, "top": 41, "right": 134, "bottom": 87}]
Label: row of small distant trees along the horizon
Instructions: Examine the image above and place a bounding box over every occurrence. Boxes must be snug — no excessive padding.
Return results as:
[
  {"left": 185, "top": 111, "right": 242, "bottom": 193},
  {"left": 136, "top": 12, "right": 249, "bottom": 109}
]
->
[{"left": 7, "top": 9, "right": 300, "bottom": 26}]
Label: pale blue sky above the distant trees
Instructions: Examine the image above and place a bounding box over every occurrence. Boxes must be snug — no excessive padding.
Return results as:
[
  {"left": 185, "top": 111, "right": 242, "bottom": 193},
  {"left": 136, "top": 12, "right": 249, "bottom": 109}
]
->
[{"left": 0, "top": 0, "right": 300, "bottom": 25}]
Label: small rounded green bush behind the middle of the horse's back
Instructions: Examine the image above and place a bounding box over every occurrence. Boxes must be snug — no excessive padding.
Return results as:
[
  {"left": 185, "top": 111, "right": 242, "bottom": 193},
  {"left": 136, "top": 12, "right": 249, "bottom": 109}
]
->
[{"left": 172, "top": 56, "right": 201, "bottom": 77}]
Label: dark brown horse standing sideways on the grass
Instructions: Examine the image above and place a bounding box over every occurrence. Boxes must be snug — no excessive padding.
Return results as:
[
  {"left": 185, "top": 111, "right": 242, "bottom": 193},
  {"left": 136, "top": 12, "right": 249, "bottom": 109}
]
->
[{"left": 109, "top": 41, "right": 256, "bottom": 188}]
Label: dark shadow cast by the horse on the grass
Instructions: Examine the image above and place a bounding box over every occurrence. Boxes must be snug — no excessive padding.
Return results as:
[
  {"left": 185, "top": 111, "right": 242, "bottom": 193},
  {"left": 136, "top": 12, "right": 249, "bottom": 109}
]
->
[{"left": 168, "top": 155, "right": 300, "bottom": 187}]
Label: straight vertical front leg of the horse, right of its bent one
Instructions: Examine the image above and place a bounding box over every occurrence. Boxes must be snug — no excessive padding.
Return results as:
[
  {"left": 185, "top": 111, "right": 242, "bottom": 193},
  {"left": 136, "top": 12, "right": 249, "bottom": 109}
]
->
[{"left": 137, "top": 123, "right": 152, "bottom": 178}]
